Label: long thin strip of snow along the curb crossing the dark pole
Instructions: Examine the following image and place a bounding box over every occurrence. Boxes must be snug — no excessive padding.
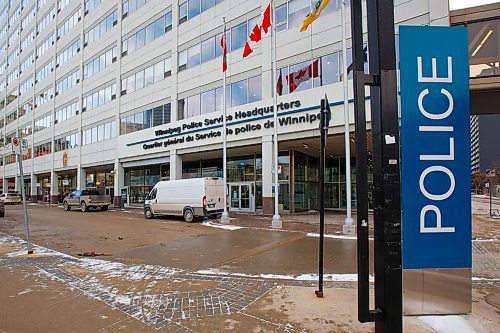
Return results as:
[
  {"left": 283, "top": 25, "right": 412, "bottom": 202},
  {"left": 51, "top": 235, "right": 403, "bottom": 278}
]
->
[{"left": 196, "top": 269, "right": 374, "bottom": 282}]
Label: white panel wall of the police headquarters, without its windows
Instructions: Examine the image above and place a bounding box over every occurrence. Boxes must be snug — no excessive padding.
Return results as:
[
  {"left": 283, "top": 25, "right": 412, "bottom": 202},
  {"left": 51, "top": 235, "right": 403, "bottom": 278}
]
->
[{"left": 0, "top": 0, "right": 448, "bottom": 201}]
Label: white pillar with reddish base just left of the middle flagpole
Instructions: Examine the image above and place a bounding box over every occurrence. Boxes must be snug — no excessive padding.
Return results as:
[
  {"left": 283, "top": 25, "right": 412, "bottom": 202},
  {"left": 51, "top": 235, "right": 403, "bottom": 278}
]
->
[{"left": 262, "top": 135, "right": 274, "bottom": 214}]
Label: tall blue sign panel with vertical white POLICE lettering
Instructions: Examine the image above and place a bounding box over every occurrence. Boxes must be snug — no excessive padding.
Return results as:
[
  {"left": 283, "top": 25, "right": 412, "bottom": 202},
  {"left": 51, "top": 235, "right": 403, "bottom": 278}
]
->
[{"left": 399, "top": 26, "right": 472, "bottom": 269}]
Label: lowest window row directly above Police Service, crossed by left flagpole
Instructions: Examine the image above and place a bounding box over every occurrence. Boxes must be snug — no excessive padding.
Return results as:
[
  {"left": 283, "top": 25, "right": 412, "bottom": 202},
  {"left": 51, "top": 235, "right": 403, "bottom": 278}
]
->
[{"left": 177, "top": 75, "right": 262, "bottom": 119}]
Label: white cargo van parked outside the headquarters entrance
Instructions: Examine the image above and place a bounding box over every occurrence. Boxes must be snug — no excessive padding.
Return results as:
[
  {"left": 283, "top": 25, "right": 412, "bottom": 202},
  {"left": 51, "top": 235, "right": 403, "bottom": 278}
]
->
[{"left": 144, "top": 178, "right": 224, "bottom": 222}]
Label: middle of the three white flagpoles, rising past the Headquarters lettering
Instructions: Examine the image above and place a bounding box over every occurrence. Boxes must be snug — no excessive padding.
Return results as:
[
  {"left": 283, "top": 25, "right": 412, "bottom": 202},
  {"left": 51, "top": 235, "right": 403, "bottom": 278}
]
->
[{"left": 271, "top": 1, "right": 282, "bottom": 229}]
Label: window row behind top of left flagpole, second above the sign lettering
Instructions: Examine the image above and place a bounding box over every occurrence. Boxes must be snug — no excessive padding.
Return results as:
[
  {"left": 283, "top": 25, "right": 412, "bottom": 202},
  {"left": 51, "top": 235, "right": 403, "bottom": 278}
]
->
[{"left": 179, "top": 17, "right": 260, "bottom": 71}]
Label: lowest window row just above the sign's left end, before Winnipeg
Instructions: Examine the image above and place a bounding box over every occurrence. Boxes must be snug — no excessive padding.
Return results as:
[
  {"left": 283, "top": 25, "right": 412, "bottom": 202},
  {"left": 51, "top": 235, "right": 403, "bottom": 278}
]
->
[{"left": 120, "top": 103, "right": 171, "bottom": 135}]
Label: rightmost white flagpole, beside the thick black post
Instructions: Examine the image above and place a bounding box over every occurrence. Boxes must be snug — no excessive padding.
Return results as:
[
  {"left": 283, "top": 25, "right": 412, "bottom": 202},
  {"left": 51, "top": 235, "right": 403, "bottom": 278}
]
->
[{"left": 340, "top": 0, "right": 355, "bottom": 234}]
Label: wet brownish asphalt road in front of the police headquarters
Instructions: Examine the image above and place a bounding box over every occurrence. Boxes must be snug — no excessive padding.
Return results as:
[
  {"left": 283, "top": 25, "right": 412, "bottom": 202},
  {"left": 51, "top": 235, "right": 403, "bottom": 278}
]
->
[{"left": 0, "top": 206, "right": 368, "bottom": 275}]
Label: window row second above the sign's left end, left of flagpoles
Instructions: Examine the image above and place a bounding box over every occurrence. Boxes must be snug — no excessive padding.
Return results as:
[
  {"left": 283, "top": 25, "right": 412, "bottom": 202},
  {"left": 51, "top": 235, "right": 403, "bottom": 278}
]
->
[{"left": 121, "top": 58, "right": 172, "bottom": 95}]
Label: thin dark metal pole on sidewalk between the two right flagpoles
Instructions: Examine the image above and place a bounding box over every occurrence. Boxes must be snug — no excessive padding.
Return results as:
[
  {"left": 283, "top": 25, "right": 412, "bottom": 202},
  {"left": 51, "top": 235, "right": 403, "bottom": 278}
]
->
[{"left": 315, "top": 99, "right": 328, "bottom": 298}]
